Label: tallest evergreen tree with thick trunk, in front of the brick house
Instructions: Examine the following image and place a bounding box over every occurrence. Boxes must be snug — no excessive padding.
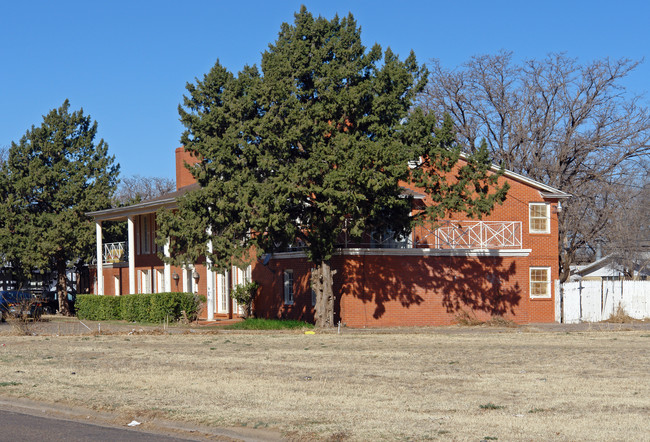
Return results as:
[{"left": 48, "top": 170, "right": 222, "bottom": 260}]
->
[{"left": 159, "top": 7, "right": 503, "bottom": 326}]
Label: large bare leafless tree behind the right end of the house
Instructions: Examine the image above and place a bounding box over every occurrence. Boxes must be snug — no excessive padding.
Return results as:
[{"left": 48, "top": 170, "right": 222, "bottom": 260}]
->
[{"left": 419, "top": 52, "right": 650, "bottom": 281}]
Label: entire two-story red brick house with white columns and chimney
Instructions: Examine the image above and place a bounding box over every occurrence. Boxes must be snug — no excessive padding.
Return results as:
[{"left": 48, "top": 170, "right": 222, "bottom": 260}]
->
[{"left": 89, "top": 148, "right": 569, "bottom": 327}]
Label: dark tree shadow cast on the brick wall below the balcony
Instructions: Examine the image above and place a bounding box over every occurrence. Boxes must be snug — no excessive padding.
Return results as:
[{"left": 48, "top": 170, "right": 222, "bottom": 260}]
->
[{"left": 341, "top": 255, "right": 522, "bottom": 319}]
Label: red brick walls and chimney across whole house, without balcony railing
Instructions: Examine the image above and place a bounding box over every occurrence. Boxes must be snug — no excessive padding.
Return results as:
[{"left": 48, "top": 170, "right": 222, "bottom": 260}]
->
[{"left": 88, "top": 153, "right": 567, "bottom": 327}]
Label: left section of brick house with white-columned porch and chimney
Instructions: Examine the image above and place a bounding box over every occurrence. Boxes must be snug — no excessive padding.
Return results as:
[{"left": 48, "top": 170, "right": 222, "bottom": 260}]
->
[{"left": 88, "top": 148, "right": 251, "bottom": 320}]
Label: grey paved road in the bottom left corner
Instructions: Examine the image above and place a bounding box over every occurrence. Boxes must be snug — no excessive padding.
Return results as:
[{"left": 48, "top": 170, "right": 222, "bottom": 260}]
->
[{"left": 0, "top": 410, "right": 190, "bottom": 442}]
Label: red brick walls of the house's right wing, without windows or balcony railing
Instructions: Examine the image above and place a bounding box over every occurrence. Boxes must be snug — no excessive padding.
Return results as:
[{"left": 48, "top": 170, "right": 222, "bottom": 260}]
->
[{"left": 253, "top": 167, "right": 559, "bottom": 327}]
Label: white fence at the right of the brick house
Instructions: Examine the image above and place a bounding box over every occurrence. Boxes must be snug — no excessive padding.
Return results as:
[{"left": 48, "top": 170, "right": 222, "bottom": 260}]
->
[{"left": 555, "top": 281, "right": 650, "bottom": 324}]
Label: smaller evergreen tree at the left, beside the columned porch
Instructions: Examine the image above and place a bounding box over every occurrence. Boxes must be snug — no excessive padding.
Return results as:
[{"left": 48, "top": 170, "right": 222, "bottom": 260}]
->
[{"left": 0, "top": 100, "right": 119, "bottom": 314}]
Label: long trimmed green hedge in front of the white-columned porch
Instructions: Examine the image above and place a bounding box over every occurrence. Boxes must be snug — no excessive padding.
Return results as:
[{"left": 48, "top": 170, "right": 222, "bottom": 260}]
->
[{"left": 75, "top": 292, "right": 199, "bottom": 322}]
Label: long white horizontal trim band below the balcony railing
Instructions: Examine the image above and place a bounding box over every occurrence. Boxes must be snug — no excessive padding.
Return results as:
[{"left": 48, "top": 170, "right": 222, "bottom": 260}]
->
[{"left": 272, "top": 248, "right": 532, "bottom": 259}]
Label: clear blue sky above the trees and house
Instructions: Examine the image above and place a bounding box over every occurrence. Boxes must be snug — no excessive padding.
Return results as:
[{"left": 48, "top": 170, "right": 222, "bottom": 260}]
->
[{"left": 0, "top": 0, "right": 650, "bottom": 178}]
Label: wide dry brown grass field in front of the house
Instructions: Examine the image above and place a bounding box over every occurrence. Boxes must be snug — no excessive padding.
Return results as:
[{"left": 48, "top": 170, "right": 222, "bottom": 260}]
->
[{"left": 0, "top": 327, "right": 650, "bottom": 441}]
